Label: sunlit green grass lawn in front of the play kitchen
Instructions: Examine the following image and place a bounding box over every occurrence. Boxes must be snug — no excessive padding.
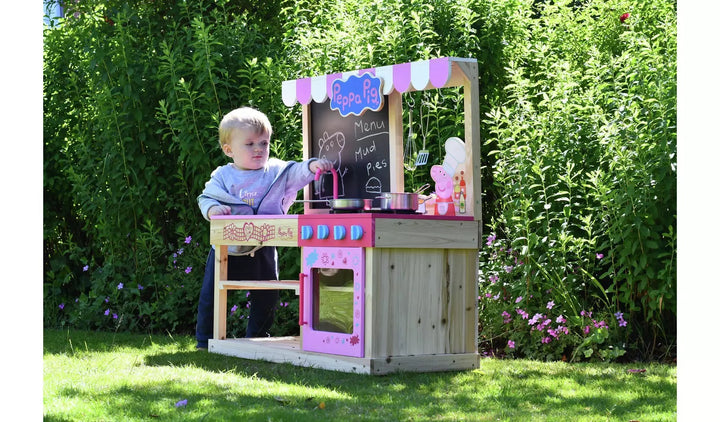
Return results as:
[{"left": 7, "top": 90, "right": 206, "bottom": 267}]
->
[{"left": 43, "top": 330, "right": 677, "bottom": 422}]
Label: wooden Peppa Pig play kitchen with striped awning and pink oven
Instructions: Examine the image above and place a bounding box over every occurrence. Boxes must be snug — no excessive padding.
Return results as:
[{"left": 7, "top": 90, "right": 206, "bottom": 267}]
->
[{"left": 209, "top": 57, "right": 482, "bottom": 374}]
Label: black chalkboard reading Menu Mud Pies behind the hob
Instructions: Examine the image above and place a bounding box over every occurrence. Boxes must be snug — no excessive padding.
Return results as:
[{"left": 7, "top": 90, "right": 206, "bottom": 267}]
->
[{"left": 310, "top": 97, "right": 390, "bottom": 208}]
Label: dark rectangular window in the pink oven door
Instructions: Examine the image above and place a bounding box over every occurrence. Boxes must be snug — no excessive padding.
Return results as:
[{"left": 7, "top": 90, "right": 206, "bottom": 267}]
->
[{"left": 312, "top": 268, "right": 353, "bottom": 334}]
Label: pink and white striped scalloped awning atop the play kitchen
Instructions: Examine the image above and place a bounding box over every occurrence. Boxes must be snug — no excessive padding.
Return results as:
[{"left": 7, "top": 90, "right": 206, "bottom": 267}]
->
[{"left": 282, "top": 57, "right": 475, "bottom": 107}]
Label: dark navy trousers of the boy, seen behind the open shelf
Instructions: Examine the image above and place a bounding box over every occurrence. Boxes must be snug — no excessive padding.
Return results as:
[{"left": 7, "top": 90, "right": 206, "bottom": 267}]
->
[{"left": 195, "top": 246, "right": 280, "bottom": 348}]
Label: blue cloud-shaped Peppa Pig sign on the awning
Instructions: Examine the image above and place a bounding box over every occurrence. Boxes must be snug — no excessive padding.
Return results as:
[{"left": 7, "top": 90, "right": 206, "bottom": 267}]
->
[{"left": 330, "top": 73, "right": 383, "bottom": 117}]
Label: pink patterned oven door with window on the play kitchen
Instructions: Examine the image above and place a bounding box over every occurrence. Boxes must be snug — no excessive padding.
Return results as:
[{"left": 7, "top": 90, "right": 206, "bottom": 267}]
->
[{"left": 300, "top": 247, "right": 365, "bottom": 357}]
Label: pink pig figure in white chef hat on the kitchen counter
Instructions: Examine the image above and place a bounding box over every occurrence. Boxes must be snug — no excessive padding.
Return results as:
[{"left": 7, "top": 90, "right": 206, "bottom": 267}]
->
[{"left": 430, "top": 136, "right": 465, "bottom": 215}]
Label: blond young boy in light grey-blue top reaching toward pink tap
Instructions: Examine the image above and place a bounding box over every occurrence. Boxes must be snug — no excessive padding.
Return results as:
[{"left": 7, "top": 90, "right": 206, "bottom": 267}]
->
[{"left": 195, "top": 107, "right": 332, "bottom": 350}]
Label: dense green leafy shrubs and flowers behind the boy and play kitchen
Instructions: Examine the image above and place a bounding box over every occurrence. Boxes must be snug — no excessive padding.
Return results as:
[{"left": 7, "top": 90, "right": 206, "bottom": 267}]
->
[{"left": 43, "top": 0, "right": 677, "bottom": 361}]
